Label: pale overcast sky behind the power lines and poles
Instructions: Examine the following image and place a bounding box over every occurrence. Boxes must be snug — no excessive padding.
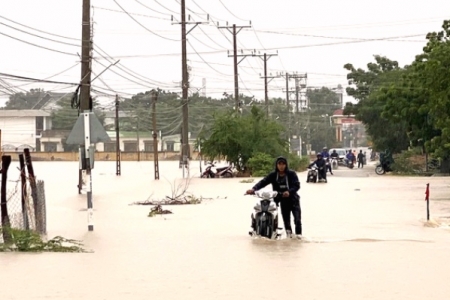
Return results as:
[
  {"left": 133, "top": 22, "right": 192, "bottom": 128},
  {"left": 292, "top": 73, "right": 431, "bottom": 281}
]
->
[{"left": 0, "top": 0, "right": 450, "bottom": 108}]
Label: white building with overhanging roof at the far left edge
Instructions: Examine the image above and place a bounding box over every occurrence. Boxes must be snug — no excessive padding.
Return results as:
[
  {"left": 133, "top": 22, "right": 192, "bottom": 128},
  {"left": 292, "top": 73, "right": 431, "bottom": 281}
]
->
[{"left": 0, "top": 109, "right": 52, "bottom": 151}]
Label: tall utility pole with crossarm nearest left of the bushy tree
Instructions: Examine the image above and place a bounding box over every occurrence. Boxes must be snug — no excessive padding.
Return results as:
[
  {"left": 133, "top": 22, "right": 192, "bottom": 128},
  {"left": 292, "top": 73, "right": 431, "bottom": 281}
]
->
[{"left": 172, "top": 0, "right": 209, "bottom": 177}]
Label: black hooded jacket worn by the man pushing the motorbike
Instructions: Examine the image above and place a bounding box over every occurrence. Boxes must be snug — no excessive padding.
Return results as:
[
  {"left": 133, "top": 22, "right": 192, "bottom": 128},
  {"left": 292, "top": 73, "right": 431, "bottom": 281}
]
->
[{"left": 253, "top": 156, "right": 300, "bottom": 199}]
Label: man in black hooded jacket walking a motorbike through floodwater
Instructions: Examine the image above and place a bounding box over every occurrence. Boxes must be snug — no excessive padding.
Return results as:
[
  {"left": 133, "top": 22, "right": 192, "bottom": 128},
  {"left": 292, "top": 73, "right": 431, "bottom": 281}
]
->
[{"left": 246, "top": 156, "right": 302, "bottom": 239}]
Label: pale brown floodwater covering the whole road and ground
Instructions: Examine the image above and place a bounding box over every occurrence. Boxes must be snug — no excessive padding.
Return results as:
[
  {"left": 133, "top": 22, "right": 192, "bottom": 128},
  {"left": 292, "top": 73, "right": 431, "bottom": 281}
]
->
[{"left": 0, "top": 161, "right": 450, "bottom": 300}]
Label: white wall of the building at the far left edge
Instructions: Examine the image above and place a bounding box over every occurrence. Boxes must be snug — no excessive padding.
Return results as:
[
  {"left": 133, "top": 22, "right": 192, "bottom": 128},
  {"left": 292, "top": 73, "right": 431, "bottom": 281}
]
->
[{"left": 0, "top": 117, "right": 36, "bottom": 148}]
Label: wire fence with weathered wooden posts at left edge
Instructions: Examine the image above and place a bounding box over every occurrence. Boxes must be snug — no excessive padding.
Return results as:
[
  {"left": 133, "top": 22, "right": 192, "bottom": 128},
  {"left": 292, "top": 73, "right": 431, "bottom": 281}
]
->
[{"left": 0, "top": 177, "right": 47, "bottom": 243}]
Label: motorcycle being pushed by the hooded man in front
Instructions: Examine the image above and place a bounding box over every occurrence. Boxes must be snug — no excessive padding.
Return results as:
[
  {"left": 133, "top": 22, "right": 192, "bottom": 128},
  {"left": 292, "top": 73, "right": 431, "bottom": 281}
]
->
[{"left": 249, "top": 191, "right": 283, "bottom": 240}]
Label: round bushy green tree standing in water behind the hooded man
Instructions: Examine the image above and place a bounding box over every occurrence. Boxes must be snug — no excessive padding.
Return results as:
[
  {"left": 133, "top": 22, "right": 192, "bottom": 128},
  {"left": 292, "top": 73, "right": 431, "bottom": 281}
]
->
[{"left": 200, "top": 106, "right": 287, "bottom": 171}]
